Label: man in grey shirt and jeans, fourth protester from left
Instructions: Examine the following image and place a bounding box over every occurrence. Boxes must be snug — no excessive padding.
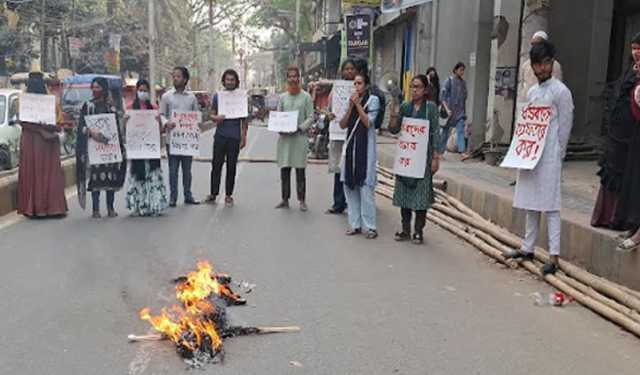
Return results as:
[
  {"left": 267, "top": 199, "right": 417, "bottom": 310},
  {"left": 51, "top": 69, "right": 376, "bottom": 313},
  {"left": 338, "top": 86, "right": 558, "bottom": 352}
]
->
[{"left": 160, "top": 66, "right": 200, "bottom": 207}]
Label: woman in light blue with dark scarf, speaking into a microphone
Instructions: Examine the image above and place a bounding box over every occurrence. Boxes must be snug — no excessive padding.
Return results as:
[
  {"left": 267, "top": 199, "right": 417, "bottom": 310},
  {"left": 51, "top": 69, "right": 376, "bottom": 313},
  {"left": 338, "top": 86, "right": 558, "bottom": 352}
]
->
[{"left": 340, "top": 72, "right": 380, "bottom": 239}]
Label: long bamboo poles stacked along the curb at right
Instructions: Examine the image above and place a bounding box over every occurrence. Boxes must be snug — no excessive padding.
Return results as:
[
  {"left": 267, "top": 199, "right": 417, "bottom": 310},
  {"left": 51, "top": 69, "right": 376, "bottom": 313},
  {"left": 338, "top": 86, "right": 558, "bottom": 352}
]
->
[{"left": 376, "top": 167, "right": 640, "bottom": 337}]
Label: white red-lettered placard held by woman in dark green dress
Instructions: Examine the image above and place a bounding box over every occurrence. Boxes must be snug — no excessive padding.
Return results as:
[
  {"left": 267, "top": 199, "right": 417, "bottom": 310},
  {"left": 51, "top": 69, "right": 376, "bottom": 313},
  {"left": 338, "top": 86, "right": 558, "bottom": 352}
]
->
[{"left": 393, "top": 117, "right": 430, "bottom": 178}]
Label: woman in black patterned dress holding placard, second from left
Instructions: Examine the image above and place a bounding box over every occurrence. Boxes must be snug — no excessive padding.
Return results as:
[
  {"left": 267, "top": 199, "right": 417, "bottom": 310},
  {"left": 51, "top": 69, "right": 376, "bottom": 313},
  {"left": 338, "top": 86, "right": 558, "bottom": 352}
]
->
[{"left": 76, "top": 77, "right": 127, "bottom": 219}]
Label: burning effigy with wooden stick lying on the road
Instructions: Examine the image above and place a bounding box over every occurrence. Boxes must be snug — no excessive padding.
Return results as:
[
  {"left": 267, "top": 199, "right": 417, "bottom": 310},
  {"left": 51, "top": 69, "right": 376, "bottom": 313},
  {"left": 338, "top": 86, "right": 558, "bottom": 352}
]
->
[{"left": 129, "top": 261, "right": 300, "bottom": 365}]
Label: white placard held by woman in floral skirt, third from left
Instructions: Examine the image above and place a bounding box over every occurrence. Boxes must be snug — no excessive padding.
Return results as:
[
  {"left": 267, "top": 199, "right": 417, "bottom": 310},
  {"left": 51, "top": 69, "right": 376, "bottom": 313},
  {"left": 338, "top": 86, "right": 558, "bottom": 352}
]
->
[{"left": 126, "top": 110, "right": 160, "bottom": 159}]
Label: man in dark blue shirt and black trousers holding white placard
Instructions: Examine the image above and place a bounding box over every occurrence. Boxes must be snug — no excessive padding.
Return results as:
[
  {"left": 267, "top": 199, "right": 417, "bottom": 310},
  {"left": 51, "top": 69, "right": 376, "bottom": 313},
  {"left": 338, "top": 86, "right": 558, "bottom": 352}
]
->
[{"left": 207, "top": 69, "right": 249, "bottom": 207}]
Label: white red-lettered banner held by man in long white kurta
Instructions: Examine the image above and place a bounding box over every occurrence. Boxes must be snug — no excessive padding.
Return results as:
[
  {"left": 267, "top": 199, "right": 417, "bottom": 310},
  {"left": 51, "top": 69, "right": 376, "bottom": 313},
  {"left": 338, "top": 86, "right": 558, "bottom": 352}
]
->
[{"left": 500, "top": 103, "right": 553, "bottom": 170}]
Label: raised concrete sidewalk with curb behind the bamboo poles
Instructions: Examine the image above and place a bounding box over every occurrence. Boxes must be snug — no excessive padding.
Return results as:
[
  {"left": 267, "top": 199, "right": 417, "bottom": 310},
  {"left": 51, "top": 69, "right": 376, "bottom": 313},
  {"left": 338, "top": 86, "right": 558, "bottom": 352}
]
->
[{"left": 378, "top": 136, "right": 640, "bottom": 290}]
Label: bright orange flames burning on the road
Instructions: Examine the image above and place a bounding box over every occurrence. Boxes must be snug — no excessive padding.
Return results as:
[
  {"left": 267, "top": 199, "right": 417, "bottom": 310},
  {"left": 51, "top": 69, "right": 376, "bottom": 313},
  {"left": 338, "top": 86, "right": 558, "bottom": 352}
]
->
[{"left": 140, "top": 261, "right": 226, "bottom": 352}]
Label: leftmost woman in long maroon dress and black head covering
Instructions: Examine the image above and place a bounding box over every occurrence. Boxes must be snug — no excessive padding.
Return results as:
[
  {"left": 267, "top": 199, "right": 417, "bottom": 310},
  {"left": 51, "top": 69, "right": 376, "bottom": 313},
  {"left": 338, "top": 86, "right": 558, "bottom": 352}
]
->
[{"left": 16, "top": 72, "right": 68, "bottom": 217}]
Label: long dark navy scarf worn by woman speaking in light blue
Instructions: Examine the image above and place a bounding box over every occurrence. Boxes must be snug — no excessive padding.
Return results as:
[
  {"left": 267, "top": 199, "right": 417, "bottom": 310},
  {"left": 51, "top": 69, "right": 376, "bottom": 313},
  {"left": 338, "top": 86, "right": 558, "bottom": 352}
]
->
[{"left": 344, "top": 92, "right": 373, "bottom": 190}]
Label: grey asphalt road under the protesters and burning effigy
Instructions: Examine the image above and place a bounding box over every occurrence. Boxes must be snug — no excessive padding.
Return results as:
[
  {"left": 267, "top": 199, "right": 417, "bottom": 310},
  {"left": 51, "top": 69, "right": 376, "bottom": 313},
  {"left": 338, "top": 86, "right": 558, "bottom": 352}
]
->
[{"left": 0, "top": 128, "right": 640, "bottom": 375}]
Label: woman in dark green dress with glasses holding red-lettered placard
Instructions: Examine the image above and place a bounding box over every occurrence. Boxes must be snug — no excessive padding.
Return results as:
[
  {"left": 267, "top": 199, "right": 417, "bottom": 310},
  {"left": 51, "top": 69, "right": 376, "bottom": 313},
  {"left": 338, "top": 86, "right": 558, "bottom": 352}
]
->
[{"left": 389, "top": 74, "right": 440, "bottom": 245}]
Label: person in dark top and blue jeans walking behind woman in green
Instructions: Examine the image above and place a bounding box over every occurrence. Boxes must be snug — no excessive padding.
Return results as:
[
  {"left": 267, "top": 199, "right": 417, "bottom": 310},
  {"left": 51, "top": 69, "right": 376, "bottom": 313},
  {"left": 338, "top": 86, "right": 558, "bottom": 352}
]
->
[{"left": 438, "top": 62, "right": 467, "bottom": 158}]
